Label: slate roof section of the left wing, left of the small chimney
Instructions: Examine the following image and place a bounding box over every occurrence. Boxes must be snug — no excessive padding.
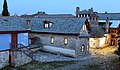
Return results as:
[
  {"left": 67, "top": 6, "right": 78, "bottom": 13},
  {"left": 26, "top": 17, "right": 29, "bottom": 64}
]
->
[{"left": 0, "top": 17, "right": 26, "bottom": 31}]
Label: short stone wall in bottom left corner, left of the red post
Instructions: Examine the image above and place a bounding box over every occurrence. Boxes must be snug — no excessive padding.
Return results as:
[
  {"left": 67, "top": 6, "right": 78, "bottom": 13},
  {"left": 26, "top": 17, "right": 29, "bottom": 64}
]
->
[{"left": 0, "top": 51, "right": 9, "bottom": 69}]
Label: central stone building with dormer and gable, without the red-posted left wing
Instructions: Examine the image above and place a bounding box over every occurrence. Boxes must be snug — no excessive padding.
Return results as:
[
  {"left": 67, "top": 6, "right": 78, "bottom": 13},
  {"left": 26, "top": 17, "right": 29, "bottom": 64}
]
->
[{"left": 29, "top": 17, "right": 90, "bottom": 57}]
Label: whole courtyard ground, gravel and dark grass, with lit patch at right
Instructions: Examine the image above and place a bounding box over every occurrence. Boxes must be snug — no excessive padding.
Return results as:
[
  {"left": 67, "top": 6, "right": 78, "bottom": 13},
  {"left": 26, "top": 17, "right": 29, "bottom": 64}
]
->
[{"left": 1, "top": 46, "right": 120, "bottom": 70}]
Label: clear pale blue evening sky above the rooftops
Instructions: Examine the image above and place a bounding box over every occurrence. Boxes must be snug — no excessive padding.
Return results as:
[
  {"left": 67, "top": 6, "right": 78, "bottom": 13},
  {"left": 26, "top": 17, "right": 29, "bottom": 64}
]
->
[{"left": 0, "top": 0, "right": 120, "bottom": 15}]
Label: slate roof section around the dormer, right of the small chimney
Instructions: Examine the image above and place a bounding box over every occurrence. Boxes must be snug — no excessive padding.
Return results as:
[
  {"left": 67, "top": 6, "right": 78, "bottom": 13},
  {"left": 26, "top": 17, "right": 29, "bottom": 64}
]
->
[{"left": 31, "top": 18, "right": 86, "bottom": 34}]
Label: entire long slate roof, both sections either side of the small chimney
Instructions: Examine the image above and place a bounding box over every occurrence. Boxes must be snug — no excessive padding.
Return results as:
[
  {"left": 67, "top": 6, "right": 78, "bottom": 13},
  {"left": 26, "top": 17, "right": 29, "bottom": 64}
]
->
[{"left": 0, "top": 17, "right": 86, "bottom": 34}]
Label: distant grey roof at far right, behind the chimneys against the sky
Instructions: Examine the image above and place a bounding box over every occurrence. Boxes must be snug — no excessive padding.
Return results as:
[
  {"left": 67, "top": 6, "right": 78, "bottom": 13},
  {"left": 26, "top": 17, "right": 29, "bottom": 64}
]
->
[{"left": 98, "top": 13, "right": 120, "bottom": 20}]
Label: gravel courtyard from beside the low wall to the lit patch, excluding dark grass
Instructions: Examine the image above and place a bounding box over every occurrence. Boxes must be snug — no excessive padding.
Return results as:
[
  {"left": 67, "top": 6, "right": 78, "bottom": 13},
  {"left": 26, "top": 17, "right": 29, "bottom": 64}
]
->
[{"left": 31, "top": 46, "right": 120, "bottom": 70}]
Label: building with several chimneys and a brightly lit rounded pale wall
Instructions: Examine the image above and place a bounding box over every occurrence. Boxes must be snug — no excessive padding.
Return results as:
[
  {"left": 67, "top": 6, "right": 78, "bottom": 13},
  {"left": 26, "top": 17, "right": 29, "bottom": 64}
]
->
[{"left": 76, "top": 7, "right": 112, "bottom": 48}]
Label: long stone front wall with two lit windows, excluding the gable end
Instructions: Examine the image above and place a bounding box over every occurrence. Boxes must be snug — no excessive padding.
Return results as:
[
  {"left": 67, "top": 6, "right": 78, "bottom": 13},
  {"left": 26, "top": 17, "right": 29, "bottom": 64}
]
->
[{"left": 29, "top": 33, "right": 77, "bottom": 50}]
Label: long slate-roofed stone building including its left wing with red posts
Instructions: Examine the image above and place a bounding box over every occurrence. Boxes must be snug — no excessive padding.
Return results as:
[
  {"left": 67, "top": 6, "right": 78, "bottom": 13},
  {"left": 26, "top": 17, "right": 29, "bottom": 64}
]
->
[{"left": 0, "top": 16, "right": 91, "bottom": 68}]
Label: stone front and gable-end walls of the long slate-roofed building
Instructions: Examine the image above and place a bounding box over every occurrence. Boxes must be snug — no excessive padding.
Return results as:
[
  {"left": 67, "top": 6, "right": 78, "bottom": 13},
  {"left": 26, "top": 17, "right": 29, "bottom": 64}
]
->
[{"left": 29, "top": 33, "right": 89, "bottom": 55}]
